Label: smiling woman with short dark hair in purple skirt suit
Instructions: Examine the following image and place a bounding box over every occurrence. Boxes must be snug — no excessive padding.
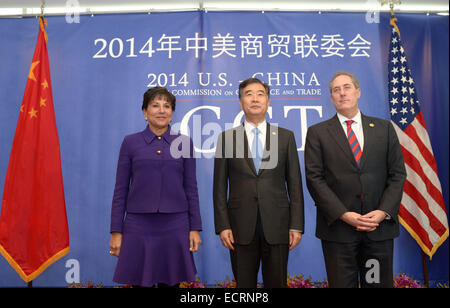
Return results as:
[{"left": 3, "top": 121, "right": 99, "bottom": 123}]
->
[{"left": 109, "top": 87, "right": 202, "bottom": 287}]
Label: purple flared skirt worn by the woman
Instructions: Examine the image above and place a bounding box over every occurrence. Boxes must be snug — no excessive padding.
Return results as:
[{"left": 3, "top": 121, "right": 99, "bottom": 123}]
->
[{"left": 113, "top": 212, "right": 197, "bottom": 287}]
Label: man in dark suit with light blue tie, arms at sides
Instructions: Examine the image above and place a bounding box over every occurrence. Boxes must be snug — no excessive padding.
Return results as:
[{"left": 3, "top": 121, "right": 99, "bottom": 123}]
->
[{"left": 213, "top": 78, "right": 304, "bottom": 288}]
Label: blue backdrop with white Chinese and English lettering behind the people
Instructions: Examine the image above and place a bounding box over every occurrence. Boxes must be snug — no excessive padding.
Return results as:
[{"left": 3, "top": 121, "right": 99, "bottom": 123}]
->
[{"left": 0, "top": 12, "right": 449, "bottom": 287}]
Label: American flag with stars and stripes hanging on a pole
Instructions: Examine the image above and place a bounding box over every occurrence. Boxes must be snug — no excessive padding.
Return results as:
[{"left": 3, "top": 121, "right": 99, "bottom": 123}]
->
[{"left": 388, "top": 18, "right": 449, "bottom": 259}]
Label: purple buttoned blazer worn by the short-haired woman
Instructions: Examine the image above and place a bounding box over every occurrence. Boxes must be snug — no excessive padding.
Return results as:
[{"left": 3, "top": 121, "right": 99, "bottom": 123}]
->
[{"left": 111, "top": 126, "right": 202, "bottom": 232}]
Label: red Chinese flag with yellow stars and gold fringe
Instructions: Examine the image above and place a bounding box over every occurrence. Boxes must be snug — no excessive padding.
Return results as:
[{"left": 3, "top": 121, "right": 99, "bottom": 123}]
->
[{"left": 0, "top": 18, "right": 69, "bottom": 282}]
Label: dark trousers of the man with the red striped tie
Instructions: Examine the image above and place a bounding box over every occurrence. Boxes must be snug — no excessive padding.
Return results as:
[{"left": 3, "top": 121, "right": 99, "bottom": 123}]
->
[{"left": 322, "top": 233, "right": 394, "bottom": 288}]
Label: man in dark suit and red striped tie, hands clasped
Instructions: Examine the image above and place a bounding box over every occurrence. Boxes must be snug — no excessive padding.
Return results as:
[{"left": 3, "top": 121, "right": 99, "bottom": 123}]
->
[{"left": 305, "top": 72, "right": 406, "bottom": 287}]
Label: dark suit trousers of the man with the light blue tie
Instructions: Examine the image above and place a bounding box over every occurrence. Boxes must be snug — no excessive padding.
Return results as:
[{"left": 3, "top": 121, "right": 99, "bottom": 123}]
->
[{"left": 230, "top": 211, "right": 289, "bottom": 288}]
